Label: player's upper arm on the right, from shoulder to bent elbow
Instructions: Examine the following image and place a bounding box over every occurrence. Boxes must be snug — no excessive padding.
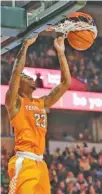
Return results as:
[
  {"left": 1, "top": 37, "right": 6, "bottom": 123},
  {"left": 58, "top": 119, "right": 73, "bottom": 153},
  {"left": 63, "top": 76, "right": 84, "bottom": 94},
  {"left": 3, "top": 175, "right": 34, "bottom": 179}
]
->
[{"left": 44, "top": 82, "right": 68, "bottom": 108}]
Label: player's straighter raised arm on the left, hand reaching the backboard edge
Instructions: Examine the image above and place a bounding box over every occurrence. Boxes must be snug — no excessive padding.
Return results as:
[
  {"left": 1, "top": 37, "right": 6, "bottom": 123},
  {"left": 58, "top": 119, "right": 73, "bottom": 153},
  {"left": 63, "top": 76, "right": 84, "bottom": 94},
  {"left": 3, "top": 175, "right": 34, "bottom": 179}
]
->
[{"left": 5, "top": 36, "right": 38, "bottom": 109}]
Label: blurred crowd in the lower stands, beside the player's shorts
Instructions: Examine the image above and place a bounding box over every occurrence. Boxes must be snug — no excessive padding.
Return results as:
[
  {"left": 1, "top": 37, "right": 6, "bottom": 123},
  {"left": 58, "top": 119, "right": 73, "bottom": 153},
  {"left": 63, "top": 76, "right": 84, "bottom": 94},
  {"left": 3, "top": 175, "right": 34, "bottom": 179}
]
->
[{"left": 1, "top": 143, "right": 102, "bottom": 194}]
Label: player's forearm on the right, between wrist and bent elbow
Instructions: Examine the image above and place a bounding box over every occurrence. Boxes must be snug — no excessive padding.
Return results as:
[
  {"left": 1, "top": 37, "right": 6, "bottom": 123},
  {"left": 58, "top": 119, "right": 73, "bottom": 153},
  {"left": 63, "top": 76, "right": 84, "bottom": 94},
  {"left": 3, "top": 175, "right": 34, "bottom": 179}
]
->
[{"left": 58, "top": 53, "right": 71, "bottom": 87}]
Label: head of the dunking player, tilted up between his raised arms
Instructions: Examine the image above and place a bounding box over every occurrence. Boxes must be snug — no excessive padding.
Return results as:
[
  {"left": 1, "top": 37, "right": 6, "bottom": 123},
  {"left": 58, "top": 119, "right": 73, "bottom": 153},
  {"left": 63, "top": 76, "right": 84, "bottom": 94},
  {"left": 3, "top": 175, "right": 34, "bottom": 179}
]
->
[{"left": 19, "top": 73, "right": 36, "bottom": 95}]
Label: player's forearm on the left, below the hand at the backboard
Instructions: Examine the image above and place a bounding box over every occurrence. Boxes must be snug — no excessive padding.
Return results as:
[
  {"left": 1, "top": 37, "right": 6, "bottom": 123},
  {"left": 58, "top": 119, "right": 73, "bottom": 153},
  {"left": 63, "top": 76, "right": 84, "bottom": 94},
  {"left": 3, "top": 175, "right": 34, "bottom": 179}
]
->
[{"left": 13, "top": 43, "right": 28, "bottom": 73}]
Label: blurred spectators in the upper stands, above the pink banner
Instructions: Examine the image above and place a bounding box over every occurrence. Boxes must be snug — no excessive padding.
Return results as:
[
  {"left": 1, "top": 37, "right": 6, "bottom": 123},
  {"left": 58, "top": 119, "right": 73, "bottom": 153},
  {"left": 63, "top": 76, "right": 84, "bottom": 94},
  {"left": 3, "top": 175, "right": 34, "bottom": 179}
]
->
[{"left": 1, "top": 36, "right": 102, "bottom": 92}]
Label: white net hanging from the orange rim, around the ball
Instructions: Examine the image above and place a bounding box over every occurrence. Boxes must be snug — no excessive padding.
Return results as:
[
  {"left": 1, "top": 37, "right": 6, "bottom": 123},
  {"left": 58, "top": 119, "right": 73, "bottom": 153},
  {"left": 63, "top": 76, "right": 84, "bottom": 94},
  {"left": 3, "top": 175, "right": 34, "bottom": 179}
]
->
[{"left": 53, "top": 20, "right": 97, "bottom": 38}]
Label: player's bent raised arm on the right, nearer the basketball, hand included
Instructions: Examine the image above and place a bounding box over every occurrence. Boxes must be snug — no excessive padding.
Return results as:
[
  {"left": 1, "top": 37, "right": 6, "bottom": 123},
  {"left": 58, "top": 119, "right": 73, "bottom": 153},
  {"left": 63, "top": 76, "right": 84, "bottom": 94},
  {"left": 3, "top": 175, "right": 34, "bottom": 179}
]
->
[{"left": 44, "top": 37, "right": 71, "bottom": 107}]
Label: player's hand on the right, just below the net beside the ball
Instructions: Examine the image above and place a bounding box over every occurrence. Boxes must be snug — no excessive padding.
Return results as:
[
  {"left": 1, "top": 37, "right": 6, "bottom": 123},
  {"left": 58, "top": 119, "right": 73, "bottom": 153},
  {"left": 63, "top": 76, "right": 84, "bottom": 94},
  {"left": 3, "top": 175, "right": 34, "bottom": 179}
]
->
[{"left": 54, "top": 37, "right": 65, "bottom": 53}]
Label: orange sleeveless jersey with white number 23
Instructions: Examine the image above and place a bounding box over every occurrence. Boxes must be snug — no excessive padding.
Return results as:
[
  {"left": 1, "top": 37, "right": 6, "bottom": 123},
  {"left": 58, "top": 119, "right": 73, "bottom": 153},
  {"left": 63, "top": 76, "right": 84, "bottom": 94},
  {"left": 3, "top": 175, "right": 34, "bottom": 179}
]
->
[{"left": 11, "top": 98, "right": 47, "bottom": 155}]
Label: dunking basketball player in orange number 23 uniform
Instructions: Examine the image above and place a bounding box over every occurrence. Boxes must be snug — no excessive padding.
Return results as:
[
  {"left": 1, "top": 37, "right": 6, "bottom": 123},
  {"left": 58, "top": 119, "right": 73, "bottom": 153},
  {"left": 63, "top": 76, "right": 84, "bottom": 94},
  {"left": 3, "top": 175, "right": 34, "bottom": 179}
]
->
[{"left": 5, "top": 36, "right": 71, "bottom": 194}]
